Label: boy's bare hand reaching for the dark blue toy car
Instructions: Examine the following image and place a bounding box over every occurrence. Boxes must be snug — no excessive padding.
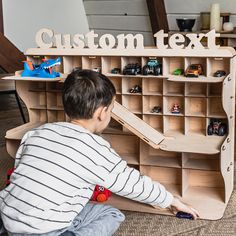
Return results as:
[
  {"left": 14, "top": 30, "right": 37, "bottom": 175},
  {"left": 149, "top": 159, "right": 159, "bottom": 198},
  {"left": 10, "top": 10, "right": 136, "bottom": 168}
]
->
[{"left": 170, "top": 197, "right": 199, "bottom": 220}]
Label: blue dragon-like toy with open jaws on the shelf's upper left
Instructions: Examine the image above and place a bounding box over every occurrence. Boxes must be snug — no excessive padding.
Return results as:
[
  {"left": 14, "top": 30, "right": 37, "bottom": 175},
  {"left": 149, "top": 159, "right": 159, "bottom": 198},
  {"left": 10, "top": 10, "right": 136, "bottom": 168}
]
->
[{"left": 21, "top": 57, "right": 61, "bottom": 78}]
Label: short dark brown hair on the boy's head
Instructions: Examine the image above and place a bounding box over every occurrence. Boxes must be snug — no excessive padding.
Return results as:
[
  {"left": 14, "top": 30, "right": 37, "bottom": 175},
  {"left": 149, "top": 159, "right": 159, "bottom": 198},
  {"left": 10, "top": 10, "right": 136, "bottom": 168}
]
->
[{"left": 62, "top": 70, "right": 116, "bottom": 119}]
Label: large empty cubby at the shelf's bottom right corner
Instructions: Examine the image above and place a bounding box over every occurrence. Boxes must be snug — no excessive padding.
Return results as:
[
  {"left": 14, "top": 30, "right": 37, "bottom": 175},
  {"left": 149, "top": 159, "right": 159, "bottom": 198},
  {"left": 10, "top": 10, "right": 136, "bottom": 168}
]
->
[{"left": 182, "top": 169, "right": 224, "bottom": 201}]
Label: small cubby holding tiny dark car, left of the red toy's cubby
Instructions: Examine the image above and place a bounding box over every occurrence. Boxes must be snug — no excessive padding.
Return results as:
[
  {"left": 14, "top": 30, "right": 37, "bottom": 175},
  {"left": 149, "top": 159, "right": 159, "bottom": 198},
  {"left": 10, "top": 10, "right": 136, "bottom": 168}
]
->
[{"left": 143, "top": 96, "right": 163, "bottom": 115}]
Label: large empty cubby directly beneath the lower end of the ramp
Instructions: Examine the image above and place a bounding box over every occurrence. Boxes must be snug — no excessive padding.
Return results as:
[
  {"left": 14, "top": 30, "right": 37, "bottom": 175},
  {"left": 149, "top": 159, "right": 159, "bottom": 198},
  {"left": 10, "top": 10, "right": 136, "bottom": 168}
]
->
[{"left": 140, "top": 141, "right": 181, "bottom": 168}]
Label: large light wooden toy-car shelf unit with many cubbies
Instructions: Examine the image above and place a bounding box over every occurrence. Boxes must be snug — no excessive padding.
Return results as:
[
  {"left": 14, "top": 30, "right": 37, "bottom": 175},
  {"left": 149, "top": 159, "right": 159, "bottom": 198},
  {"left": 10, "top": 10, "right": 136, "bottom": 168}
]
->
[{"left": 5, "top": 45, "right": 236, "bottom": 220}]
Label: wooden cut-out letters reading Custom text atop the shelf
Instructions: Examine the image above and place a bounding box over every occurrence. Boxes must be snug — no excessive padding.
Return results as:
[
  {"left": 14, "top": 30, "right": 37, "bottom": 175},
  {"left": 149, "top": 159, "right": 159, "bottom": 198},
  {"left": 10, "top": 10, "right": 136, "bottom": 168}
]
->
[{"left": 36, "top": 28, "right": 220, "bottom": 50}]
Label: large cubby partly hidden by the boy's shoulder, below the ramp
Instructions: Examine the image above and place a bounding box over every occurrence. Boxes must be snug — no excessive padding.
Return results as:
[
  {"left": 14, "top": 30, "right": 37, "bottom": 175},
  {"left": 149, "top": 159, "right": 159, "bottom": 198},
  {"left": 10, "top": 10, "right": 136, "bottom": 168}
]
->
[{"left": 102, "top": 133, "right": 139, "bottom": 165}]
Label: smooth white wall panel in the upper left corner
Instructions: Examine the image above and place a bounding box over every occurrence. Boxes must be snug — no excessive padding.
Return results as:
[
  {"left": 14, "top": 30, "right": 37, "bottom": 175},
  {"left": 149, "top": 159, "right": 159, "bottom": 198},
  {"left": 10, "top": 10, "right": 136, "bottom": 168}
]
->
[{"left": 3, "top": 0, "right": 89, "bottom": 51}]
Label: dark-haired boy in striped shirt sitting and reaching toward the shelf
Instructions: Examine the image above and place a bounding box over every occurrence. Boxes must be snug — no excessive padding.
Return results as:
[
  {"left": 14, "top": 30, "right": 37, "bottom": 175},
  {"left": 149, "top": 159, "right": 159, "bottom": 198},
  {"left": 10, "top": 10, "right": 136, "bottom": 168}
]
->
[{"left": 0, "top": 70, "right": 198, "bottom": 236}]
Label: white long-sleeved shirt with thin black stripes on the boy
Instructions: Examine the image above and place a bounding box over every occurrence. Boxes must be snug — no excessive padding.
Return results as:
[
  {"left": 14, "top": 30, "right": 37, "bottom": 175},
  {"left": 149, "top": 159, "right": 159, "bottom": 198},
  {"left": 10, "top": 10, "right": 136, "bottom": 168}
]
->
[{"left": 0, "top": 122, "right": 173, "bottom": 234}]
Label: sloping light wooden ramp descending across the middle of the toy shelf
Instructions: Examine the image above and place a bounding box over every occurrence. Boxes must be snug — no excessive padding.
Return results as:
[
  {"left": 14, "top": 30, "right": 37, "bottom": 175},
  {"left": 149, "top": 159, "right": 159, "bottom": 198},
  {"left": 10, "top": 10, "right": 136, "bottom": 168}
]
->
[{"left": 112, "top": 102, "right": 164, "bottom": 148}]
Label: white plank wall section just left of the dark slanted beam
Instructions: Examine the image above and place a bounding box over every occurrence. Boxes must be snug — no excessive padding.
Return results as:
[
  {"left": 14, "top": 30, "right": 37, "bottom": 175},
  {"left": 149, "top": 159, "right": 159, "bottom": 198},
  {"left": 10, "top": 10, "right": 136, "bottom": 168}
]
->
[{"left": 84, "top": 0, "right": 154, "bottom": 45}]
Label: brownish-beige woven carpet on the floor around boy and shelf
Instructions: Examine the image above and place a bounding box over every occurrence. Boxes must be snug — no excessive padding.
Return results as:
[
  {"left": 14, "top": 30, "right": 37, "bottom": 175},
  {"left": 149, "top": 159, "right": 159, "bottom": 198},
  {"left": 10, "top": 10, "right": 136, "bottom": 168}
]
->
[{"left": 0, "top": 95, "right": 236, "bottom": 236}]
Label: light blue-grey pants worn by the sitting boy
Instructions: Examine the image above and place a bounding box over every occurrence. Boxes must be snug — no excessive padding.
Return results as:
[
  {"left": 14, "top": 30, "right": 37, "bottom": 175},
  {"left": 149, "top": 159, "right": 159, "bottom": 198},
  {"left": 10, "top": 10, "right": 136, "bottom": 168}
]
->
[{"left": 0, "top": 203, "right": 125, "bottom": 236}]
